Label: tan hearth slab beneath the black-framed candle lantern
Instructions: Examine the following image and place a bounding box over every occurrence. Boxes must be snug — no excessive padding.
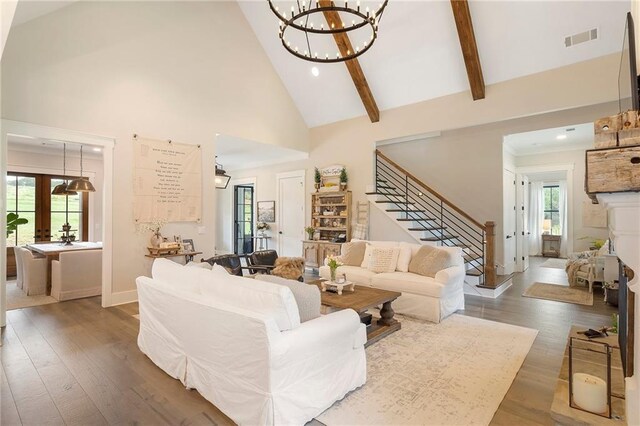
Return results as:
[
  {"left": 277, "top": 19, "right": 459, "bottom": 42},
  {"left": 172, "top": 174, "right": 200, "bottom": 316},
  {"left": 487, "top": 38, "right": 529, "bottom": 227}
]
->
[{"left": 551, "top": 325, "right": 627, "bottom": 426}]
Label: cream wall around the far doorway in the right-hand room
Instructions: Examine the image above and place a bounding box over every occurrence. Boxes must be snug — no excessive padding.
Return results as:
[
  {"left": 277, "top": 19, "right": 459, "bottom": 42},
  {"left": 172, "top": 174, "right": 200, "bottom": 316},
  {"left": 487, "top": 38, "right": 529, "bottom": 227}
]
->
[{"left": 515, "top": 150, "right": 609, "bottom": 251}]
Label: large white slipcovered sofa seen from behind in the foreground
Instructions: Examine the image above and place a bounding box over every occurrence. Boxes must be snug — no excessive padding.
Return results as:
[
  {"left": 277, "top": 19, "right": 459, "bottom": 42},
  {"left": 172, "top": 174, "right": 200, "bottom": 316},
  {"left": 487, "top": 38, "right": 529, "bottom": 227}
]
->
[{"left": 136, "top": 259, "right": 367, "bottom": 425}]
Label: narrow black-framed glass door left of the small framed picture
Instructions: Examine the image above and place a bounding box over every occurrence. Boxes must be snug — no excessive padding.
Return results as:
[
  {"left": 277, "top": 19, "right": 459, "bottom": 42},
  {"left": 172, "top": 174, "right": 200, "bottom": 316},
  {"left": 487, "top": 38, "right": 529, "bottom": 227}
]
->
[{"left": 233, "top": 185, "right": 254, "bottom": 254}]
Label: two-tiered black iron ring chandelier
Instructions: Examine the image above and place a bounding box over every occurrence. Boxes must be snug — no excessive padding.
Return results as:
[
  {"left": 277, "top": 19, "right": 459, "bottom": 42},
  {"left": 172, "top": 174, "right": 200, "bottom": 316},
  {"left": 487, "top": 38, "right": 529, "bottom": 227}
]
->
[{"left": 267, "top": 0, "right": 389, "bottom": 63}]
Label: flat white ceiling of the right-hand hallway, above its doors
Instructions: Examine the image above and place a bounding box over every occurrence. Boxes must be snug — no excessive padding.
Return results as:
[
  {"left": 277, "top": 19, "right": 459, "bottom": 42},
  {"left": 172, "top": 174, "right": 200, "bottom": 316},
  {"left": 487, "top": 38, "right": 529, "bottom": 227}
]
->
[{"left": 504, "top": 123, "right": 593, "bottom": 156}]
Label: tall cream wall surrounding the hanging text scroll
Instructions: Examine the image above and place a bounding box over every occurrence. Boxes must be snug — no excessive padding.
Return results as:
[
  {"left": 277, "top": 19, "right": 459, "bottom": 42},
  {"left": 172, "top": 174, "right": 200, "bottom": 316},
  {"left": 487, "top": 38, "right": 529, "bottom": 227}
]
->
[{"left": 2, "top": 2, "right": 308, "bottom": 297}]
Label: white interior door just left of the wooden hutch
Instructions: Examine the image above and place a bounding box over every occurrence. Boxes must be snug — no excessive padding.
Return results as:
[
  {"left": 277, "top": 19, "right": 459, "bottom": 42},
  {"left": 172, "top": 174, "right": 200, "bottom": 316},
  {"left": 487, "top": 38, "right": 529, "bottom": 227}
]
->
[{"left": 276, "top": 170, "right": 305, "bottom": 256}]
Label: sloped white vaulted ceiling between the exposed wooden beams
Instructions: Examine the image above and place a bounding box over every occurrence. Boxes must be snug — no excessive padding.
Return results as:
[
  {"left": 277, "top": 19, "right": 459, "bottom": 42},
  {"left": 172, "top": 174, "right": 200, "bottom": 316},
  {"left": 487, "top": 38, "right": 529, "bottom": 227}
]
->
[{"left": 240, "top": 0, "right": 630, "bottom": 127}]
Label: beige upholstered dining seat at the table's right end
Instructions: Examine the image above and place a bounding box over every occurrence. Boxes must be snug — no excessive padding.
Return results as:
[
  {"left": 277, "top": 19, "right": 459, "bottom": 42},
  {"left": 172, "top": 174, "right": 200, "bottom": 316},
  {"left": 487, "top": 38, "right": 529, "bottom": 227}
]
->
[{"left": 51, "top": 250, "right": 102, "bottom": 301}]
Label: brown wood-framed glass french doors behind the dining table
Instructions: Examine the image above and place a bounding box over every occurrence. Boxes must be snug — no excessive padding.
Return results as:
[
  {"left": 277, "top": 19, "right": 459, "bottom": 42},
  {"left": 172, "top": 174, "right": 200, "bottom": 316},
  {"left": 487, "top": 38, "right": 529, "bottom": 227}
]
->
[{"left": 7, "top": 172, "right": 89, "bottom": 247}]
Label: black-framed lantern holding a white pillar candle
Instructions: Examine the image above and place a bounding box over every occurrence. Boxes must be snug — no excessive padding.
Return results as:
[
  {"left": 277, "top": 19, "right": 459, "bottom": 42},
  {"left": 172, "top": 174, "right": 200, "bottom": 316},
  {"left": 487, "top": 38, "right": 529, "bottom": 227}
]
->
[{"left": 569, "top": 337, "right": 612, "bottom": 419}]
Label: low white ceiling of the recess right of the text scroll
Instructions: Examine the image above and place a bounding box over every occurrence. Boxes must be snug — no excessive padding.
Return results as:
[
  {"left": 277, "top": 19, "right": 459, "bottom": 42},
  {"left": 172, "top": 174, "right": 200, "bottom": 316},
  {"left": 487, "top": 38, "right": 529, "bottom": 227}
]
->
[{"left": 216, "top": 135, "right": 309, "bottom": 171}]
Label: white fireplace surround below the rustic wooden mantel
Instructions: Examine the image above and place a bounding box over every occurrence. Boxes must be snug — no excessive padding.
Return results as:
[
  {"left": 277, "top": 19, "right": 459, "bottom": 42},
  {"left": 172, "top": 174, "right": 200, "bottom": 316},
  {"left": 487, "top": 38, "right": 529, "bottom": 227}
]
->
[{"left": 598, "top": 192, "right": 640, "bottom": 425}]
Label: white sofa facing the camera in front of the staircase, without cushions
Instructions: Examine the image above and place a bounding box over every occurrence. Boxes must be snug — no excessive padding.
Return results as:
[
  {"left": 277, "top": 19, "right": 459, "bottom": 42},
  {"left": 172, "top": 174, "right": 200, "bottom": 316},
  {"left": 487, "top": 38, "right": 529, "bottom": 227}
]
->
[{"left": 320, "top": 241, "right": 466, "bottom": 323}]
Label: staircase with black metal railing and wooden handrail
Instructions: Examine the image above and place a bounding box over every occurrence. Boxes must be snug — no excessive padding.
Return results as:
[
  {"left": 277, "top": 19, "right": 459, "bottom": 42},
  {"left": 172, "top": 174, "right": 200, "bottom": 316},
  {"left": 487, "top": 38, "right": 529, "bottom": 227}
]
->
[{"left": 367, "top": 150, "right": 496, "bottom": 288}]
